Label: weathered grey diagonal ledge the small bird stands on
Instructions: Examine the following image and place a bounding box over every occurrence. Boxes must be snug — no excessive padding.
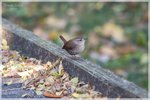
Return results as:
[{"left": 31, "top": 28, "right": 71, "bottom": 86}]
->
[{"left": 2, "top": 19, "right": 148, "bottom": 98}]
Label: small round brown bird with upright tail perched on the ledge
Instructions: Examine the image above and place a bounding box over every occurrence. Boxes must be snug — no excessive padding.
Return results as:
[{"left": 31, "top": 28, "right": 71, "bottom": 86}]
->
[{"left": 60, "top": 35, "right": 85, "bottom": 55}]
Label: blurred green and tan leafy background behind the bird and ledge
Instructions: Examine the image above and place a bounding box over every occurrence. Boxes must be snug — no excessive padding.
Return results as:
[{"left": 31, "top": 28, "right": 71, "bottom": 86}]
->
[{"left": 2, "top": 2, "right": 148, "bottom": 90}]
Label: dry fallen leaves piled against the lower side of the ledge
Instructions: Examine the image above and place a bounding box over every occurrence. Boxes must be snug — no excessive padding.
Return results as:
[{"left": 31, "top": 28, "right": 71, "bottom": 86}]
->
[{"left": 0, "top": 39, "right": 106, "bottom": 98}]
